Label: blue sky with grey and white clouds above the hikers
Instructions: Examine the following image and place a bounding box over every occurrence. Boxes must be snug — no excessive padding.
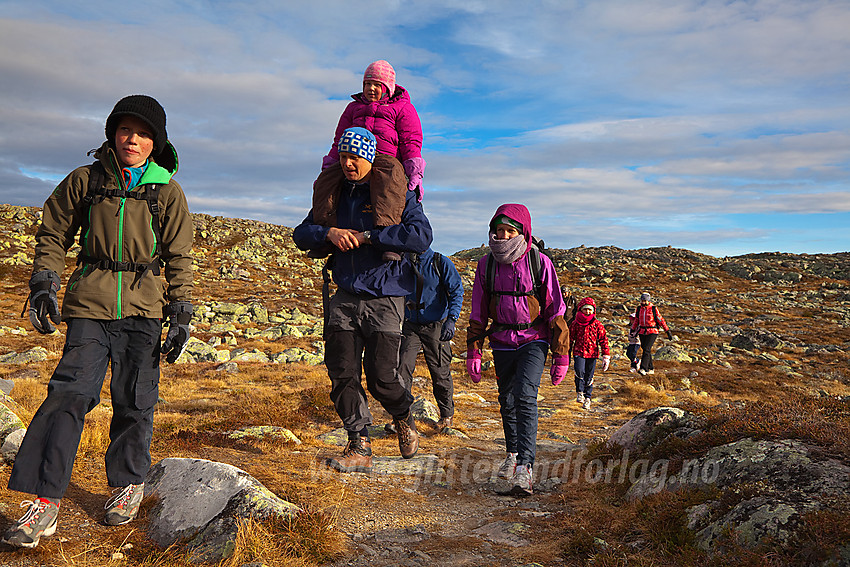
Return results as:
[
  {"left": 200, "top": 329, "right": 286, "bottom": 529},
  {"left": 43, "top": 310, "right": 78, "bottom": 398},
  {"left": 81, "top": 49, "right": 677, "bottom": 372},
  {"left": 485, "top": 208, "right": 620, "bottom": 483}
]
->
[{"left": 0, "top": 0, "right": 850, "bottom": 256}]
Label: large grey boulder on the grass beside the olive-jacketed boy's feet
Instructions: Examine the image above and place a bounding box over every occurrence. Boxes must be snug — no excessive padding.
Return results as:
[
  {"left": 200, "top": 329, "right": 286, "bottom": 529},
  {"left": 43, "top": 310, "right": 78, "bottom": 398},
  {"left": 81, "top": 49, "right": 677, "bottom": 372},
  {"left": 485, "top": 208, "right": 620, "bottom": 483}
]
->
[{"left": 145, "top": 458, "right": 301, "bottom": 562}]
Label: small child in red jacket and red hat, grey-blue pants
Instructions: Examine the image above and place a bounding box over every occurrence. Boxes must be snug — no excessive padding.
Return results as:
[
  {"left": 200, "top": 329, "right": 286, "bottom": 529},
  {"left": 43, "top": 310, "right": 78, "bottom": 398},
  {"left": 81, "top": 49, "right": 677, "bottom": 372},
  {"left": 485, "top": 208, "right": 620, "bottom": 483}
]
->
[{"left": 570, "top": 297, "right": 611, "bottom": 410}]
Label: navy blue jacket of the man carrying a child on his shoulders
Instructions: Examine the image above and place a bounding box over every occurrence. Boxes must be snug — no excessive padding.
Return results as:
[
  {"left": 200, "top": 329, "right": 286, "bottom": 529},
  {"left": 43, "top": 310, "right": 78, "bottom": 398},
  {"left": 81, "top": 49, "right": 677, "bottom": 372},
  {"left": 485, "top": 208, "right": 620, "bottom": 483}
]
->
[{"left": 292, "top": 181, "right": 433, "bottom": 297}]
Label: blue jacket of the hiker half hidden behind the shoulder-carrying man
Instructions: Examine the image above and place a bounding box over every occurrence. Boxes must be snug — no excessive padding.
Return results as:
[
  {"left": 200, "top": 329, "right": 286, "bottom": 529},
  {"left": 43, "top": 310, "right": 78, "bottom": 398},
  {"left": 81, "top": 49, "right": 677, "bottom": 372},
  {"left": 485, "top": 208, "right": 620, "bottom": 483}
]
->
[{"left": 404, "top": 248, "right": 463, "bottom": 324}]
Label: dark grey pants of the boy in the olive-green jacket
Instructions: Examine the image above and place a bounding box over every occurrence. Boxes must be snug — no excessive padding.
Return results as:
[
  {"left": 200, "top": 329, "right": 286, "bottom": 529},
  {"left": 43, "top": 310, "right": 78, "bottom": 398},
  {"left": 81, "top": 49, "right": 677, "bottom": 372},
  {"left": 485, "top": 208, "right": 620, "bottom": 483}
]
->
[{"left": 9, "top": 317, "right": 162, "bottom": 499}]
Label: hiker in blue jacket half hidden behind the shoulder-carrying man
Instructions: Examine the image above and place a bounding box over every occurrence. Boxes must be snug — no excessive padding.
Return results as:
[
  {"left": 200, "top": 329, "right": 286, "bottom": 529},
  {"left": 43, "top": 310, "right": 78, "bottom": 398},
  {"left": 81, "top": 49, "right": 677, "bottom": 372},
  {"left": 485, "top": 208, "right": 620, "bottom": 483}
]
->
[{"left": 398, "top": 248, "right": 463, "bottom": 431}]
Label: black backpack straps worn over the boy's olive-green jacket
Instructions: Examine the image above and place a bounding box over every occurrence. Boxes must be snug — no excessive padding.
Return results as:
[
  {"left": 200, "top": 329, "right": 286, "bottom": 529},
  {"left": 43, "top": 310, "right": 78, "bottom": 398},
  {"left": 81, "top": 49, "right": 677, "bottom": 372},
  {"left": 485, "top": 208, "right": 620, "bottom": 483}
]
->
[{"left": 77, "top": 161, "right": 162, "bottom": 284}]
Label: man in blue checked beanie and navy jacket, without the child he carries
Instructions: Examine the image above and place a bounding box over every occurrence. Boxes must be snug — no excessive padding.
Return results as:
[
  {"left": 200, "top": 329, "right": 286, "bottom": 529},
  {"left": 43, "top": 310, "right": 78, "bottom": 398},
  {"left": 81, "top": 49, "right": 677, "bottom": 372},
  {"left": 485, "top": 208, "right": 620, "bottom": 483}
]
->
[{"left": 293, "top": 128, "right": 432, "bottom": 472}]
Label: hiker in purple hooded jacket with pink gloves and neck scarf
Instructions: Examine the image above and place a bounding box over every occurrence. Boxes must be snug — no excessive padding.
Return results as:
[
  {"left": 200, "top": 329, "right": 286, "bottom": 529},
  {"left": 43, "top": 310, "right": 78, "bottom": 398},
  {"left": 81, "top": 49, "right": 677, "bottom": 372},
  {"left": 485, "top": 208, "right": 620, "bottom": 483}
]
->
[{"left": 466, "top": 204, "right": 570, "bottom": 496}]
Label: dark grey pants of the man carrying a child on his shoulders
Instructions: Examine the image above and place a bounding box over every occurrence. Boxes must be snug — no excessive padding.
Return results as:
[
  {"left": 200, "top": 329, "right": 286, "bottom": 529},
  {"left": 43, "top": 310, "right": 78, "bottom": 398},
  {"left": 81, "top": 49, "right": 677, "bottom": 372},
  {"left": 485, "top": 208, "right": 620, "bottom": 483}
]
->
[{"left": 325, "top": 289, "right": 413, "bottom": 432}]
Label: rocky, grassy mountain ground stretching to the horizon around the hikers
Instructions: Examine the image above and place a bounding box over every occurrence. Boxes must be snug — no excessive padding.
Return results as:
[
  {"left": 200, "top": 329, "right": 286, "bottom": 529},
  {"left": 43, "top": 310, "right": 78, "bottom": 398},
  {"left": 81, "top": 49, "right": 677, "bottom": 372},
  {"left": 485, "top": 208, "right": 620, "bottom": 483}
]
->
[{"left": 0, "top": 205, "right": 850, "bottom": 566}]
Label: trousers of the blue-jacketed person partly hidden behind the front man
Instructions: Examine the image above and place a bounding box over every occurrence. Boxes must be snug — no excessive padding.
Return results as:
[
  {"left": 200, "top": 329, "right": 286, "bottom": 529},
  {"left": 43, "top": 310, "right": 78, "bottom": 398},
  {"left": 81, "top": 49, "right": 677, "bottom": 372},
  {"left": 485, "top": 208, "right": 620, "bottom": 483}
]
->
[{"left": 398, "top": 321, "right": 455, "bottom": 417}]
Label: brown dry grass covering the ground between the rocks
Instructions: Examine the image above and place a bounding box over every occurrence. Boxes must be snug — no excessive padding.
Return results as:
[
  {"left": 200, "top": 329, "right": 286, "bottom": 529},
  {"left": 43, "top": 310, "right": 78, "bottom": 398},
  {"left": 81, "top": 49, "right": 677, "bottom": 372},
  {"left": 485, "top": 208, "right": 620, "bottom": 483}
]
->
[{"left": 0, "top": 206, "right": 850, "bottom": 567}]
